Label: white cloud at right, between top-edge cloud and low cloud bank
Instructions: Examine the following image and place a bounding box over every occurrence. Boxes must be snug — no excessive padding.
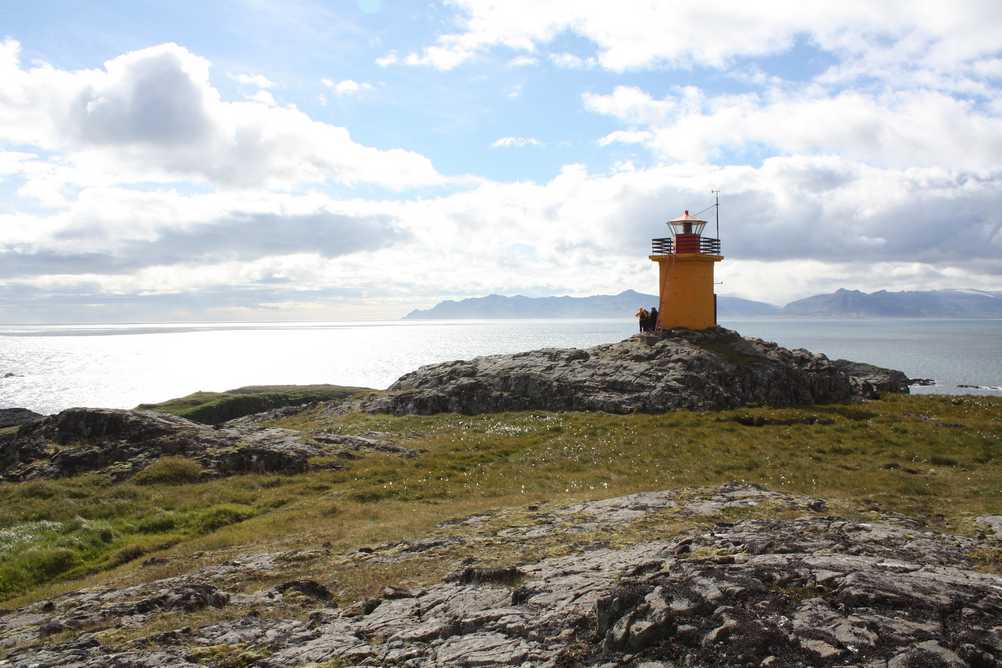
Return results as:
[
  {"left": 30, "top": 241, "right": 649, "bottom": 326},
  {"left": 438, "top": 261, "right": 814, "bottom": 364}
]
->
[{"left": 583, "top": 86, "right": 1002, "bottom": 169}]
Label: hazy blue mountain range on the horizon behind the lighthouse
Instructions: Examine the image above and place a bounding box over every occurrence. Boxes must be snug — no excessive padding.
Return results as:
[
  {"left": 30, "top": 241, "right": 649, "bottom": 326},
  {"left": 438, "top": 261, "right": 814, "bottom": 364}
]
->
[{"left": 404, "top": 289, "right": 1002, "bottom": 320}]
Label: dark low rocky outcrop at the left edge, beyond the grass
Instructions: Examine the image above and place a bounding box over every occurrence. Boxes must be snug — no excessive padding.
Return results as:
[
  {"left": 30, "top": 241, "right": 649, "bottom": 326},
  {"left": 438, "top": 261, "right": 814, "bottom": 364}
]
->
[{"left": 0, "top": 409, "right": 413, "bottom": 481}]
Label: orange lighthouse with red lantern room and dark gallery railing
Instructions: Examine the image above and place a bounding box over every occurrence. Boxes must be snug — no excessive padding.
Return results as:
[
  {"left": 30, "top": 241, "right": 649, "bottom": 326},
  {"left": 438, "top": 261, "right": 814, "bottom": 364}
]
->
[{"left": 650, "top": 210, "right": 723, "bottom": 329}]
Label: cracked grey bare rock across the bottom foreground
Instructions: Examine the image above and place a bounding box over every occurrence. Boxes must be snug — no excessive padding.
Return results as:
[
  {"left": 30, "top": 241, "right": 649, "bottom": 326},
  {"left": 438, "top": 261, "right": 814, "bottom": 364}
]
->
[{"left": 0, "top": 484, "right": 1002, "bottom": 668}]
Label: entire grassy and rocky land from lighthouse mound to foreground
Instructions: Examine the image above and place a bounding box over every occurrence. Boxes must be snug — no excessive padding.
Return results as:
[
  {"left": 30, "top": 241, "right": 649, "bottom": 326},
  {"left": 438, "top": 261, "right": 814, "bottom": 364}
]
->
[{"left": 0, "top": 328, "right": 1002, "bottom": 668}]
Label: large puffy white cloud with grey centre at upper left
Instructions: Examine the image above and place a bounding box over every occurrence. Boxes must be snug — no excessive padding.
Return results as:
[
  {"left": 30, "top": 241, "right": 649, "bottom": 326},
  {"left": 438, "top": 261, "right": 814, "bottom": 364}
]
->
[{"left": 0, "top": 40, "right": 444, "bottom": 188}]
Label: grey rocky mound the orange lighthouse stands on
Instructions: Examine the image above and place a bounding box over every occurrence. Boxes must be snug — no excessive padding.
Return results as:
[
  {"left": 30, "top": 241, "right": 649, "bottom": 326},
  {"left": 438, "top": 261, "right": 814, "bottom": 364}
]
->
[{"left": 364, "top": 327, "right": 908, "bottom": 415}]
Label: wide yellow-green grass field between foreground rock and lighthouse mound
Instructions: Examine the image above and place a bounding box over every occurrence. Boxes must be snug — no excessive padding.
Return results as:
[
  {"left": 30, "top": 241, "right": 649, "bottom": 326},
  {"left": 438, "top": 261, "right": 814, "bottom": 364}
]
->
[{"left": 0, "top": 396, "right": 1002, "bottom": 607}]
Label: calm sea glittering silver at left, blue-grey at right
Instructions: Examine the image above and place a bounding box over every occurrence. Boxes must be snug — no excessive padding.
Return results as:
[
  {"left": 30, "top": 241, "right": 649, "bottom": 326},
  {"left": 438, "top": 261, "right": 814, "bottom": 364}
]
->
[{"left": 0, "top": 319, "right": 1002, "bottom": 413}]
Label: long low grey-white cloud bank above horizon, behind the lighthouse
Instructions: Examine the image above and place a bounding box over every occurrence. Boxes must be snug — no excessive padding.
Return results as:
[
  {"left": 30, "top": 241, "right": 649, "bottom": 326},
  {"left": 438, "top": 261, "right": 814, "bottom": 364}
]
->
[{"left": 0, "top": 157, "right": 1002, "bottom": 313}]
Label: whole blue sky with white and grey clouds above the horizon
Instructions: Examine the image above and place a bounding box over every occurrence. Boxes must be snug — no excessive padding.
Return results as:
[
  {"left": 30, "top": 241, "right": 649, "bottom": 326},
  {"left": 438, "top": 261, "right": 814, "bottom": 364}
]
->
[{"left": 0, "top": 0, "right": 1002, "bottom": 323}]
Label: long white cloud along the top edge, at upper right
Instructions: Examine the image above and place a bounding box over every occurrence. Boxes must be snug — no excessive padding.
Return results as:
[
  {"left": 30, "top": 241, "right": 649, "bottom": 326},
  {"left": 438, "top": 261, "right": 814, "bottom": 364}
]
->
[{"left": 393, "top": 0, "right": 1002, "bottom": 79}]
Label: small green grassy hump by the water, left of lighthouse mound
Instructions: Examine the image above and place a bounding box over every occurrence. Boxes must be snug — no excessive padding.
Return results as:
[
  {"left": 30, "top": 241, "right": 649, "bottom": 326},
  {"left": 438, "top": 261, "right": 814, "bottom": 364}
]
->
[{"left": 136, "top": 385, "right": 372, "bottom": 425}]
